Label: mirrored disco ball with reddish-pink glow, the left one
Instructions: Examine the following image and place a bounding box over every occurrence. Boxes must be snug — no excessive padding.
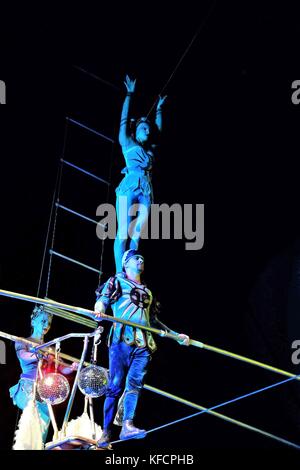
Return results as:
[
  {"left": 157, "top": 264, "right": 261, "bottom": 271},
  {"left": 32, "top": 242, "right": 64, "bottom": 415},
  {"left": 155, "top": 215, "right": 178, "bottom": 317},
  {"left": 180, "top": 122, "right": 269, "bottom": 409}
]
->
[{"left": 37, "top": 373, "right": 70, "bottom": 405}]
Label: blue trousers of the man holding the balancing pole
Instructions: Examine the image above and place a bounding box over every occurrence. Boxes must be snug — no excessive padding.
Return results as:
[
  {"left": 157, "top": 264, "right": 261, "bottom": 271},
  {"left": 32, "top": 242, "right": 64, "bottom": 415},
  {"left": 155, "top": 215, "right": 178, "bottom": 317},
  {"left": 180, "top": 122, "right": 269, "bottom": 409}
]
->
[{"left": 103, "top": 342, "right": 151, "bottom": 431}]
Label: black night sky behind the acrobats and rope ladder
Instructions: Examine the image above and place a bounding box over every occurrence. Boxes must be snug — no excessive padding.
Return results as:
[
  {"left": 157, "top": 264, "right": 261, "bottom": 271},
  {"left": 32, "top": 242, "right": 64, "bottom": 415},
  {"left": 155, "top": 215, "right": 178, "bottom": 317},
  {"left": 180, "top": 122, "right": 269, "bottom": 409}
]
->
[{"left": 0, "top": 1, "right": 300, "bottom": 460}]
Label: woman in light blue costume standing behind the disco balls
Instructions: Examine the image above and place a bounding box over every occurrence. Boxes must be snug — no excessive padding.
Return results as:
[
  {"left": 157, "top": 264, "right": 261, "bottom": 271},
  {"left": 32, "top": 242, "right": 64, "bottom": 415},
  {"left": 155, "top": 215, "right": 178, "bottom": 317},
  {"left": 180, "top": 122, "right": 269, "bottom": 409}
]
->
[{"left": 9, "top": 305, "right": 77, "bottom": 442}]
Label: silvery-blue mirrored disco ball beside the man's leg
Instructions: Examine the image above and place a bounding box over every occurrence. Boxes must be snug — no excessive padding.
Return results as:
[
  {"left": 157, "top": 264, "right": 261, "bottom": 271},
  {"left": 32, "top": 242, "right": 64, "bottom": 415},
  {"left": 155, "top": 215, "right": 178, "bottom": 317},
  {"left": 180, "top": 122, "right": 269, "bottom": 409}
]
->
[{"left": 78, "top": 365, "right": 108, "bottom": 398}]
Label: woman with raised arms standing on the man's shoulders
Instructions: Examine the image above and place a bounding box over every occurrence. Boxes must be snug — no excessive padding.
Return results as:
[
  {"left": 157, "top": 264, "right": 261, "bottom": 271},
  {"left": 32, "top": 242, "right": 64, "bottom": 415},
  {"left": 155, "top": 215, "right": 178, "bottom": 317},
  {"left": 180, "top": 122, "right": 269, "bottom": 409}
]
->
[{"left": 114, "top": 75, "right": 166, "bottom": 273}]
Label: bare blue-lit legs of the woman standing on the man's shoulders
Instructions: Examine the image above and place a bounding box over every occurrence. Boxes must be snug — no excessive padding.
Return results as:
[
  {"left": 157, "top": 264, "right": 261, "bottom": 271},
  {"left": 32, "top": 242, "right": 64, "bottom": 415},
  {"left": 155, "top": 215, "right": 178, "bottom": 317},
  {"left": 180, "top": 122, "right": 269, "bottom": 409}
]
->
[{"left": 114, "top": 190, "right": 151, "bottom": 273}]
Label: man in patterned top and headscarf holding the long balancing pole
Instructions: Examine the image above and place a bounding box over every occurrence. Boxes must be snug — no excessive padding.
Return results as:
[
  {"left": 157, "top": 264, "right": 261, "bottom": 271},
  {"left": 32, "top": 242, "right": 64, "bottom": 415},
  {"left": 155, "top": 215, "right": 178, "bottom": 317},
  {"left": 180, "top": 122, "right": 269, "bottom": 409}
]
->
[{"left": 95, "top": 250, "right": 189, "bottom": 447}]
